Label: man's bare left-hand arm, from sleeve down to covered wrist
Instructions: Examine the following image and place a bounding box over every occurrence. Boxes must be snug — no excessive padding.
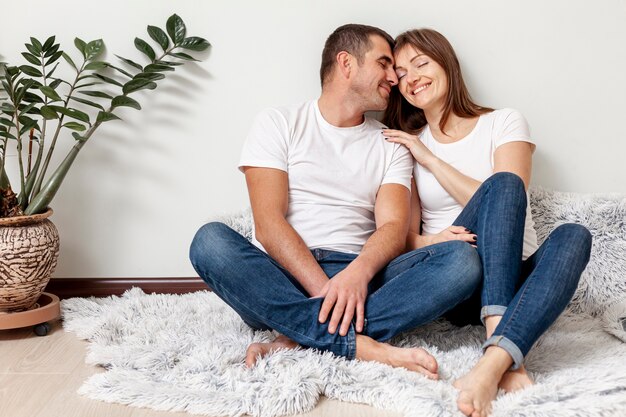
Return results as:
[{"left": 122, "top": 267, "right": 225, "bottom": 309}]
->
[{"left": 244, "top": 167, "right": 328, "bottom": 296}]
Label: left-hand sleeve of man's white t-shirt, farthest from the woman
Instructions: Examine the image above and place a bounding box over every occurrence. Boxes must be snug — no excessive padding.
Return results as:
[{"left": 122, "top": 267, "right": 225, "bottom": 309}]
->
[{"left": 239, "top": 109, "right": 289, "bottom": 172}]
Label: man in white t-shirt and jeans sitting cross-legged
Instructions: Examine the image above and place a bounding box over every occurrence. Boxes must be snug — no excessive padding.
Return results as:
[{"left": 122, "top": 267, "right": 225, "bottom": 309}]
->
[{"left": 190, "top": 24, "right": 481, "bottom": 378}]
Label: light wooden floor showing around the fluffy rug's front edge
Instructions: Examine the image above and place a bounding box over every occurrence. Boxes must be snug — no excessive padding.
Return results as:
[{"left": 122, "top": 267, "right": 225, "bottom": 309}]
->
[{"left": 0, "top": 321, "right": 399, "bottom": 417}]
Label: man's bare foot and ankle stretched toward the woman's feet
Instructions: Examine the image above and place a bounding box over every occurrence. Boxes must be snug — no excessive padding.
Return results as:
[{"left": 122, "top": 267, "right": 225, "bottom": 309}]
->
[{"left": 356, "top": 335, "right": 439, "bottom": 379}]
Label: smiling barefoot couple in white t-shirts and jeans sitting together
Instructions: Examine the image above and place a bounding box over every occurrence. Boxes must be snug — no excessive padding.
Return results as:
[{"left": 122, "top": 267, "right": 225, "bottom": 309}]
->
[{"left": 190, "top": 24, "right": 591, "bottom": 416}]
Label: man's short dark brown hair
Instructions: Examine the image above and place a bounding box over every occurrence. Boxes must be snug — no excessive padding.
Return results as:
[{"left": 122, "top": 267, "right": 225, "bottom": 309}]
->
[{"left": 320, "top": 23, "right": 394, "bottom": 86}]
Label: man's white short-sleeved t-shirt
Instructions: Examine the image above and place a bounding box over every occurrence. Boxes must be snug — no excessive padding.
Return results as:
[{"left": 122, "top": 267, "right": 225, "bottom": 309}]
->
[{"left": 239, "top": 100, "right": 413, "bottom": 253}]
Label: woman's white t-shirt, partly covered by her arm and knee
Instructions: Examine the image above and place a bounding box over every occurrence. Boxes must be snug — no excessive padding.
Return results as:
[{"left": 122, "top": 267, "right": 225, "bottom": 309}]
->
[{"left": 414, "top": 109, "right": 537, "bottom": 259}]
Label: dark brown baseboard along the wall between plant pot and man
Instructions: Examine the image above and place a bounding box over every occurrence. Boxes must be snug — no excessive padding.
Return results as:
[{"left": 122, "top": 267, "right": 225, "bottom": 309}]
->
[{"left": 45, "top": 277, "right": 209, "bottom": 298}]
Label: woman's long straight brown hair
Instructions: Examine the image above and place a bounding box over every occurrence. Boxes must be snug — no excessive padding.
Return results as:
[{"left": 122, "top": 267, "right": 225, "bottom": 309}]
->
[{"left": 383, "top": 29, "right": 493, "bottom": 134}]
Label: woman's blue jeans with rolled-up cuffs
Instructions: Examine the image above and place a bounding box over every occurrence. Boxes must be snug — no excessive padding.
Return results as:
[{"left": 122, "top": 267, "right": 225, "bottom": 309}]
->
[{"left": 454, "top": 172, "right": 591, "bottom": 369}]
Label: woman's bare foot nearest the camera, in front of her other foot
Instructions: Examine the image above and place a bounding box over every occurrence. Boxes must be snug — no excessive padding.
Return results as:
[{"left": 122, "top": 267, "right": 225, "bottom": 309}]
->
[{"left": 453, "top": 346, "right": 513, "bottom": 417}]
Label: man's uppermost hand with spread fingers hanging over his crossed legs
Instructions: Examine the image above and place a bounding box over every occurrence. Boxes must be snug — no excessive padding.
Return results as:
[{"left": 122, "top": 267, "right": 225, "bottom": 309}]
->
[{"left": 318, "top": 269, "right": 368, "bottom": 336}]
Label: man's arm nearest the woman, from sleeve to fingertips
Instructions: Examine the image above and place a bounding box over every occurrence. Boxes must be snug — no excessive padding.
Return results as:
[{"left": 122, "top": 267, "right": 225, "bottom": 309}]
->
[{"left": 319, "top": 184, "right": 410, "bottom": 336}]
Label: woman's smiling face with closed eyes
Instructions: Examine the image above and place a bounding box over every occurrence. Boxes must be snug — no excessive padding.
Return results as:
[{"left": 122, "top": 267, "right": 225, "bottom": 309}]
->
[{"left": 395, "top": 45, "right": 448, "bottom": 111}]
